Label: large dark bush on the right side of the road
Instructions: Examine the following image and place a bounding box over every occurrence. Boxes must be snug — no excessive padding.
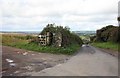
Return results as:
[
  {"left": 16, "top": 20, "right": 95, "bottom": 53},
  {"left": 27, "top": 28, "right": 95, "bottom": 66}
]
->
[{"left": 96, "top": 25, "right": 119, "bottom": 42}]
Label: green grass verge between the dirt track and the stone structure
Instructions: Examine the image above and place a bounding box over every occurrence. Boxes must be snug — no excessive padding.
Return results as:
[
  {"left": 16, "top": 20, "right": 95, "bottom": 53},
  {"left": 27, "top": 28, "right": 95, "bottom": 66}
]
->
[{"left": 9, "top": 43, "right": 80, "bottom": 55}]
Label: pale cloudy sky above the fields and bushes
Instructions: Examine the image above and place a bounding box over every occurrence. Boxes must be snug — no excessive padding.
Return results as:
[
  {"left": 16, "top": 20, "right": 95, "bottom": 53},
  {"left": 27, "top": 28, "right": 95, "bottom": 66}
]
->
[{"left": 0, "top": 0, "right": 119, "bottom": 31}]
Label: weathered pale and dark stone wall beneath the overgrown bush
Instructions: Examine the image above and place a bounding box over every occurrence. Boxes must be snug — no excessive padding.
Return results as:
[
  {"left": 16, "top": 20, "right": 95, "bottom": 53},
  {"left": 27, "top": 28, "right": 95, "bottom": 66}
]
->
[{"left": 38, "top": 32, "right": 62, "bottom": 47}]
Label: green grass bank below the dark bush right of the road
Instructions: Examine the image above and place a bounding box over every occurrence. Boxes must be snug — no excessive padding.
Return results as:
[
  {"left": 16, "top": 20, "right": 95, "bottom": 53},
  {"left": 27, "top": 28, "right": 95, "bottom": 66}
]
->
[{"left": 92, "top": 42, "right": 120, "bottom": 51}]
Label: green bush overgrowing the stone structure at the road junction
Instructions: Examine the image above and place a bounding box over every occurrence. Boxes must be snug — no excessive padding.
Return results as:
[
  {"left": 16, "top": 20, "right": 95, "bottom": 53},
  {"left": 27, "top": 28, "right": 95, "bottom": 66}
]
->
[{"left": 37, "top": 24, "right": 83, "bottom": 47}]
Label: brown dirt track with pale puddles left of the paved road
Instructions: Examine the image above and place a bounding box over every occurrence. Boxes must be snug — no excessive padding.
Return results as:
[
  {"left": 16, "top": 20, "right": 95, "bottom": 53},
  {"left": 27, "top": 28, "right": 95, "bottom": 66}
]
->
[{"left": 1, "top": 46, "right": 70, "bottom": 76}]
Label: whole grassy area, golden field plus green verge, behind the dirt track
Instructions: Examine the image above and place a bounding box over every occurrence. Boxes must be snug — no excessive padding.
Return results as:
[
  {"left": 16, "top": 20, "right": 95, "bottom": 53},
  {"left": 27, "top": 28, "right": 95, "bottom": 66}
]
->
[{"left": 2, "top": 35, "right": 80, "bottom": 55}]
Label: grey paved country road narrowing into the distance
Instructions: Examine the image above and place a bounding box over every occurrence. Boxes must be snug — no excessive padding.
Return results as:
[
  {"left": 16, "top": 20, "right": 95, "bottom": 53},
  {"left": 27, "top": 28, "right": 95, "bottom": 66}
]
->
[{"left": 26, "top": 46, "right": 118, "bottom": 76}]
